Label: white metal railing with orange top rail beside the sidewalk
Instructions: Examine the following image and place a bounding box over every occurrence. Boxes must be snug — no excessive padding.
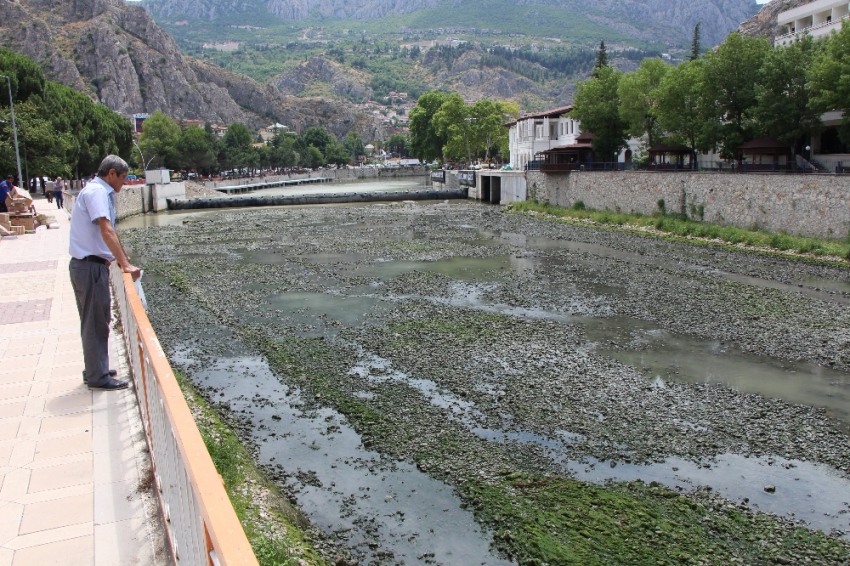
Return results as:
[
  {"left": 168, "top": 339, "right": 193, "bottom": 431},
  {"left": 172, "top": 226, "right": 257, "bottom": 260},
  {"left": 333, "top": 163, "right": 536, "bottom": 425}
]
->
[{"left": 112, "top": 265, "right": 258, "bottom": 566}]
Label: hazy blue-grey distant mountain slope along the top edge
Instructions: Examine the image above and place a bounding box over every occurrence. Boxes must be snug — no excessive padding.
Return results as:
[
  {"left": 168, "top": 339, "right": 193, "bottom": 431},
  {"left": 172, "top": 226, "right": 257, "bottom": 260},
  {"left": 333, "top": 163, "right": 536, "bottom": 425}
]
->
[{"left": 145, "top": 0, "right": 758, "bottom": 46}]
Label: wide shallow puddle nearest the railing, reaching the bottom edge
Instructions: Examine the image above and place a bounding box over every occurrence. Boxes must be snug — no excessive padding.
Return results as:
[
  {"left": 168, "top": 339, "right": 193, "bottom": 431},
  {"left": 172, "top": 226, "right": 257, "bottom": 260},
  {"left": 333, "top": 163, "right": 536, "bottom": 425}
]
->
[{"left": 173, "top": 350, "right": 513, "bottom": 566}]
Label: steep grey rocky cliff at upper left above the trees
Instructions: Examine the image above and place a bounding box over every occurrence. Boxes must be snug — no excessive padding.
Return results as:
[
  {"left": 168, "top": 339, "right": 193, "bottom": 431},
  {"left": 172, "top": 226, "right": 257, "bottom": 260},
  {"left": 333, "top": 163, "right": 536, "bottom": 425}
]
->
[{"left": 0, "top": 0, "right": 380, "bottom": 136}]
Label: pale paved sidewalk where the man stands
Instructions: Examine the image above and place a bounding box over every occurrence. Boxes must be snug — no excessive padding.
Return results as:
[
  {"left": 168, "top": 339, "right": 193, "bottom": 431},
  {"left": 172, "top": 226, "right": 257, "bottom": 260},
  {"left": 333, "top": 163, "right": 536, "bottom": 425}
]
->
[{"left": 0, "top": 199, "right": 168, "bottom": 566}]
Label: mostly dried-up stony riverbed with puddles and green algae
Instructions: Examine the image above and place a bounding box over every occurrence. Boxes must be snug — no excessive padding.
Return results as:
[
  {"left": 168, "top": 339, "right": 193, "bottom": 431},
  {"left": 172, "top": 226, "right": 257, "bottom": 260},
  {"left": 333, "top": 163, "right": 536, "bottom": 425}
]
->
[{"left": 122, "top": 203, "right": 850, "bottom": 565}]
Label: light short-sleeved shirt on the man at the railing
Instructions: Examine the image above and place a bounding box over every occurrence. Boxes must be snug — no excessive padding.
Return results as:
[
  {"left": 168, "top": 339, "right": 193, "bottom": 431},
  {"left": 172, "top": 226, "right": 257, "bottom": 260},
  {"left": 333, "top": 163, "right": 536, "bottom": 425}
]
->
[{"left": 69, "top": 177, "right": 116, "bottom": 261}]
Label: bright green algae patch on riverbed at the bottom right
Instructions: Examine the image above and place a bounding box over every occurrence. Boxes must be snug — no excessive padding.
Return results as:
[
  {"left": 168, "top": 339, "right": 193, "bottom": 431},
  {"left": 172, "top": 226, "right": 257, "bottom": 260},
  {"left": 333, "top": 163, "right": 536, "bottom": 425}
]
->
[{"left": 460, "top": 473, "right": 848, "bottom": 565}]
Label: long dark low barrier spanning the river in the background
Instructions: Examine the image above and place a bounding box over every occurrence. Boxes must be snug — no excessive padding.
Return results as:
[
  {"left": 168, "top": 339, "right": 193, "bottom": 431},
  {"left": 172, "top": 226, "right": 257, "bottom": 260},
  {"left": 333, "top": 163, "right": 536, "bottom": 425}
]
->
[{"left": 168, "top": 188, "right": 467, "bottom": 210}]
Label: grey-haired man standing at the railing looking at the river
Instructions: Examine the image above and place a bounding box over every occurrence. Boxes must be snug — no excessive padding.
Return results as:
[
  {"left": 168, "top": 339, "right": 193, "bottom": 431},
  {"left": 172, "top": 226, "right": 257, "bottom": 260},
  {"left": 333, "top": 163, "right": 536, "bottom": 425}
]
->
[{"left": 70, "top": 155, "right": 141, "bottom": 391}]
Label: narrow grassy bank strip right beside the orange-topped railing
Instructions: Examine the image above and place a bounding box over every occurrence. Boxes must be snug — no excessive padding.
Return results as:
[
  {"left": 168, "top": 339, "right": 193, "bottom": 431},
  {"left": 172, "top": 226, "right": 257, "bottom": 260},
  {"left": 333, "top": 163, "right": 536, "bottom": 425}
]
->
[{"left": 174, "top": 371, "right": 329, "bottom": 566}]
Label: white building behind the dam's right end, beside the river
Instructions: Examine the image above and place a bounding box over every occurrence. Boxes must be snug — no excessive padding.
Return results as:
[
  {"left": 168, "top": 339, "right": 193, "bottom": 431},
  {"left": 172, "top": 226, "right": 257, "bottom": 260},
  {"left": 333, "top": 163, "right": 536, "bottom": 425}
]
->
[{"left": 507, "top": 106, "right": 581, "bottom": 170}]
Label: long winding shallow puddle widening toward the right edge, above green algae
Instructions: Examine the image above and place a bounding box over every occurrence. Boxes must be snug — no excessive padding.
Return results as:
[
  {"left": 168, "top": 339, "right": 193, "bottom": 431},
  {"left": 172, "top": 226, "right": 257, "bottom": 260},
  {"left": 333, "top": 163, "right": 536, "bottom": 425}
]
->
[{"left": 342, "top": 352, "right": 850, "bottom": 538}]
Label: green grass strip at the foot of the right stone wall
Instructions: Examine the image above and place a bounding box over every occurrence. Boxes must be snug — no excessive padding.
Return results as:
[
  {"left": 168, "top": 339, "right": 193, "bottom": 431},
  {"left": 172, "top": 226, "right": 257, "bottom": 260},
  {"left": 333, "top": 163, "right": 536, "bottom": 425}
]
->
[{"left": 511, "top": 200, "right": 850, "bottom": 260}]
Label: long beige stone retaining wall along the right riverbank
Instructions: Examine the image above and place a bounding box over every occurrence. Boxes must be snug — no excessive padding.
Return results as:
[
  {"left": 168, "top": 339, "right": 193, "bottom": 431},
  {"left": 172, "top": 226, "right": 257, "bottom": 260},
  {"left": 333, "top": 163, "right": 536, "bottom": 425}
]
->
[{"left": 526, "top": 171, "right": 850, "bottom": 238}]
